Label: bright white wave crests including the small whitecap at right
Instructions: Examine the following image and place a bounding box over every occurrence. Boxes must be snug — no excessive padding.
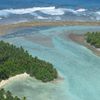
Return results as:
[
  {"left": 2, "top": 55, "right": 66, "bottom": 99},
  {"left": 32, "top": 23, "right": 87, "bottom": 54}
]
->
[{"left": 0, "top": 7, "right": 86, "bottom": 16}]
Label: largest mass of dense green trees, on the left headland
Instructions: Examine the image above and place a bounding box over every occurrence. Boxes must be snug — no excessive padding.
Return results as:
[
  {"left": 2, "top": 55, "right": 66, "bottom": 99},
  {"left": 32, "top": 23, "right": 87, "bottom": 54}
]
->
[{"left": 0, "top": 41, "right": 57, "bottom": 82}]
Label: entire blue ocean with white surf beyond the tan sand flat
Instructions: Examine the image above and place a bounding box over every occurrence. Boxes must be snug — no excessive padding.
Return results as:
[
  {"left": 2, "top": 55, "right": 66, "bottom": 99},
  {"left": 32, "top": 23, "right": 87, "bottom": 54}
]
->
[{"left": 0, "top": 0, "right": 100, "bottom": 24}]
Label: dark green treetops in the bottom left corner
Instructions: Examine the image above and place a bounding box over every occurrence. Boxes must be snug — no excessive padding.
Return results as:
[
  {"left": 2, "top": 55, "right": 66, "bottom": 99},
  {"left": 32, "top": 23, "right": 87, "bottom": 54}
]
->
[{"left": 0, "top": 89, "right": 26, "bottom": 100}]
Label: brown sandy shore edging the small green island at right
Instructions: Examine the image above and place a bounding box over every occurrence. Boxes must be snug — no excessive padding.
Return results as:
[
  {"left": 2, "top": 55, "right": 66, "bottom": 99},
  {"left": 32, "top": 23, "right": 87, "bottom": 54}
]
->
[{"left": 69, "top": 34, "right": 100, "bottom": 56}]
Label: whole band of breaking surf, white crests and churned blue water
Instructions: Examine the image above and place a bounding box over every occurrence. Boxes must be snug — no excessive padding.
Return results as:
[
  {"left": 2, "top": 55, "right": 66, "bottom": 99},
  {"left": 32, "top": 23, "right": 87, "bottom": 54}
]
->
[{"left": 0, "top": 6, "right": 100, "bottom": 20}]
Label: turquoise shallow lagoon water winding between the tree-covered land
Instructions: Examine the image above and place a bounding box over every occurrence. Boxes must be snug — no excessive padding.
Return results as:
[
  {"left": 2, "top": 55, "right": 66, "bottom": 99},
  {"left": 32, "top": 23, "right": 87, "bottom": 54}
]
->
[{"left": 0, "top": 26, "right": 100, "bottom": 100}]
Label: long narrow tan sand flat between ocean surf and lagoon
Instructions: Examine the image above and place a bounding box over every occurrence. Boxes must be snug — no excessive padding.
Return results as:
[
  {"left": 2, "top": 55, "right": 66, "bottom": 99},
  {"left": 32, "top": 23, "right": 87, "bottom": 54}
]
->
[{"left": 0, "top": 21, "right": 100, "bottom": 34}]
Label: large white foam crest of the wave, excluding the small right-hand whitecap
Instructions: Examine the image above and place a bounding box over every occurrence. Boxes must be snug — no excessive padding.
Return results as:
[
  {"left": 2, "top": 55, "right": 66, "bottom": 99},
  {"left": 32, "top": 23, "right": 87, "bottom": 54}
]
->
[{"left": 0, "top": 7, "right": 64, "bottom": 15}]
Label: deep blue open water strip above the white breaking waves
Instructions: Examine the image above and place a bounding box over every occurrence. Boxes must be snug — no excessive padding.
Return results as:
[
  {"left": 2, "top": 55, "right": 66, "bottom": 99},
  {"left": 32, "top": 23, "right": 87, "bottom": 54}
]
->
[{"left": 0, "top": 0, "right": 100, "bottom": 9}]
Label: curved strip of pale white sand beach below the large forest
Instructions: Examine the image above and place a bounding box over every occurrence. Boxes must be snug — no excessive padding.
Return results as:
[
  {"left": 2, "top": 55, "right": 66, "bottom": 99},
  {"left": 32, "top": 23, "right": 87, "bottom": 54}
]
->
[{"left": 0, "top": 73, "right": 29, "bottom": 88}]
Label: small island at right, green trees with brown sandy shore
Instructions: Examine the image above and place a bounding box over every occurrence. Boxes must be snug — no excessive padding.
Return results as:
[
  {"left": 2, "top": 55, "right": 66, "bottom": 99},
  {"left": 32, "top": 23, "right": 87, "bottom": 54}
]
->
[{"left": 69, "top": 32, "right": 100, "bottom": 56}]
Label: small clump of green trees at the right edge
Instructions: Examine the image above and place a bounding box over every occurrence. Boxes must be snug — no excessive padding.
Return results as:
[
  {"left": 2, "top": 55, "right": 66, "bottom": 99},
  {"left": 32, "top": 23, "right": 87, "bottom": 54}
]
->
[{"left": 85, "top": 32, "right": 100, "bottom": 48}]
